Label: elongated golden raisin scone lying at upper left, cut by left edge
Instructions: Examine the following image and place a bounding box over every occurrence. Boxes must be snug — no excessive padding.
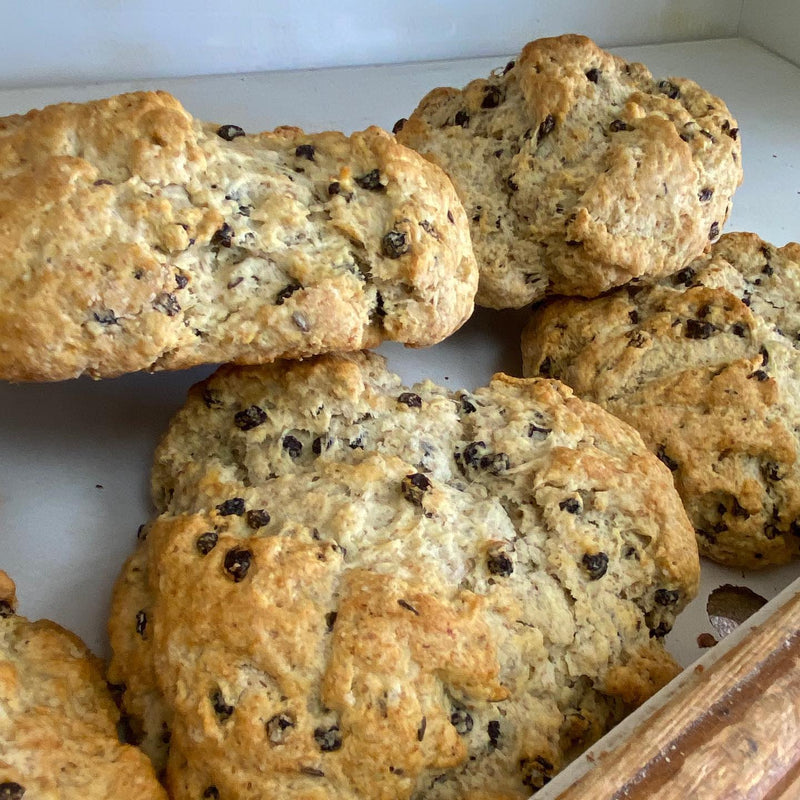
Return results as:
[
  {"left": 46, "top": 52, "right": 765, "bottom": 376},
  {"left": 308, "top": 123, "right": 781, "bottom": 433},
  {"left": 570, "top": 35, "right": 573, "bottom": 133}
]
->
[{"left": 0, "top": 92, "right": 477, "bottom": 380}]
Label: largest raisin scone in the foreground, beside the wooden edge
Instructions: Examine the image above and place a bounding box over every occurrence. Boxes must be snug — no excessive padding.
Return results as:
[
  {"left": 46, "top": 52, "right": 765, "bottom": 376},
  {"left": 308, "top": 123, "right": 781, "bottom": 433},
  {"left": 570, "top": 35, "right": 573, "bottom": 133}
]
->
[{"left": 110, "top": 354, "right": 698, "bottom": 800}]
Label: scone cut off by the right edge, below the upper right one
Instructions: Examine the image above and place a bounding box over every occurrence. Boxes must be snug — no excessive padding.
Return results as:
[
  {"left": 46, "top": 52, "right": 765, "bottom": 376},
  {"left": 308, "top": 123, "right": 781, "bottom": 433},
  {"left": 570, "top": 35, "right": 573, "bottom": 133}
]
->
[{"left": 522, "top": 233, "right": 800, "bottom": 567}]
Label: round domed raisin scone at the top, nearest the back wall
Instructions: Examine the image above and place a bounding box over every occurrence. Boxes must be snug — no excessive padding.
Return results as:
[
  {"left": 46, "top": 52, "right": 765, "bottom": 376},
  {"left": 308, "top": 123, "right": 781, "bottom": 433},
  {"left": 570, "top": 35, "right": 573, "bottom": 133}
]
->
[{"left": 395, "top": 35, "right": 742, "bottom": 308}]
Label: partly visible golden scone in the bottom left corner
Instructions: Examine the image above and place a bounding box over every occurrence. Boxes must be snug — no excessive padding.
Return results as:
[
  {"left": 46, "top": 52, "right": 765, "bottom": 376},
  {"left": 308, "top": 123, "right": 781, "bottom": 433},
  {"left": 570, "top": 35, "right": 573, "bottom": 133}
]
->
[{"left": 0, "top": 571, "right": 166, "bottom": 800}]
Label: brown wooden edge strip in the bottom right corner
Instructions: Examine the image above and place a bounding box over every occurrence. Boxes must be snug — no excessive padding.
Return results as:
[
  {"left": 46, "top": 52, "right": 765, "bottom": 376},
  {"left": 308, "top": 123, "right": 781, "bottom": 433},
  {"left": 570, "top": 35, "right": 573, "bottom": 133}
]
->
[{"left": 558, "top": 593, "right": 800, "bottom": 800}]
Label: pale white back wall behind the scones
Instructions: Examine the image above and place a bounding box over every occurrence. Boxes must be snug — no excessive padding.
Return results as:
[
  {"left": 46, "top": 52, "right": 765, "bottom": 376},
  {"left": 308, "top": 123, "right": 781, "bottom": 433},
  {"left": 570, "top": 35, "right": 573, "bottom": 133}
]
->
[{"left": 0, "top": 0, "right": 744, "bottom": 88}]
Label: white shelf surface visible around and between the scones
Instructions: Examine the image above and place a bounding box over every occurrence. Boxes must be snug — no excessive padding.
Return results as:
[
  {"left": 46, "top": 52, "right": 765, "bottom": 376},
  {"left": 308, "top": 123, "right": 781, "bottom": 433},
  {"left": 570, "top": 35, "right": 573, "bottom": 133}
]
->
[{"left": 0, "top": 40, "right": 800, "bottom": 676}]
